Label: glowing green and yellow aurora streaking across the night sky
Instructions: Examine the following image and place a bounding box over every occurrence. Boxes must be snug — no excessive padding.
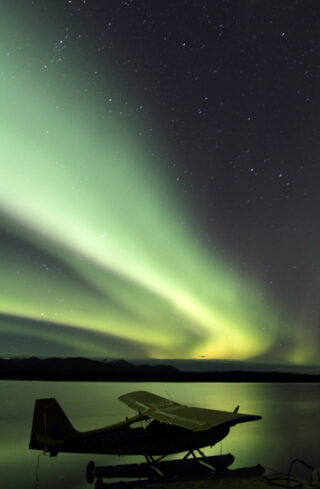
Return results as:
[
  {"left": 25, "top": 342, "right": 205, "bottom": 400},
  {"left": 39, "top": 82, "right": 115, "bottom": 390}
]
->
[{"left": 0, "top": 4, "right": 312, "bottom": 362}]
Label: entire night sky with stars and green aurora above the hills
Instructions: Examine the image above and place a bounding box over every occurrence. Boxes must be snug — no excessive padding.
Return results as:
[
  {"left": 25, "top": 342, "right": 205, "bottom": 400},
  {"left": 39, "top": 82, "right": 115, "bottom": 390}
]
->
[{"left": 0, "top": 0, "right": 320, "bottom": 364}]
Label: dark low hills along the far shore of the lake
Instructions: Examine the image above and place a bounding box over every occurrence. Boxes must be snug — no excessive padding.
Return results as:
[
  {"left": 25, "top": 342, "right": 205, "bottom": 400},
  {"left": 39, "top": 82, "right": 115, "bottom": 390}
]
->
[{"left": 0, "top": 357, "right": 320, "bottom": 382}]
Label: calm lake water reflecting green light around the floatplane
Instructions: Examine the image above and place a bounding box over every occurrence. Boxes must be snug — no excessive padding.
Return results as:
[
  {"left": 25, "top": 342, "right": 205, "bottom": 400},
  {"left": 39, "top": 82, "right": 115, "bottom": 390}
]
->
[{"left": 0, "top": 381, "right": 320, "bottom": 489}]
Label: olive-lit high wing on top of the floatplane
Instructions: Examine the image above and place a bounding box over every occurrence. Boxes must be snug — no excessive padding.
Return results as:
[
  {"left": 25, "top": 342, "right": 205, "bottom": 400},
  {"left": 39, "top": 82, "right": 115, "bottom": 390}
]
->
[{"left": 119, "top": 391, "right": 261, "bottom": 431}]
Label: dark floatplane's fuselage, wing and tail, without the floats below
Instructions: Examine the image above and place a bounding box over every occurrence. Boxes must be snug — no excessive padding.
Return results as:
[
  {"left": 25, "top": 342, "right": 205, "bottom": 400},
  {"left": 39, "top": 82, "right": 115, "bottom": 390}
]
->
[{"left": 29, "top": 391, "right": 261, "bottom": 461}]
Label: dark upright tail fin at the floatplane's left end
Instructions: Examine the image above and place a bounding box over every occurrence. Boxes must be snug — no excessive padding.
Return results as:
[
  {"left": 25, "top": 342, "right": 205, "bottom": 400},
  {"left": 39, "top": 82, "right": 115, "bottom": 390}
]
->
[{"left": 29, "top": 398, "right": 78, "bottom": 452}]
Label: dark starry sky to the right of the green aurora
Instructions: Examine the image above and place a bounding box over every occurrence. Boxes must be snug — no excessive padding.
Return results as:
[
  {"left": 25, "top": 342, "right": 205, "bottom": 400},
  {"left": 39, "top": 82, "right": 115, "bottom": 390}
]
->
[{"left": 69, "top": 0, "right": 320, "bottom": 306}]
